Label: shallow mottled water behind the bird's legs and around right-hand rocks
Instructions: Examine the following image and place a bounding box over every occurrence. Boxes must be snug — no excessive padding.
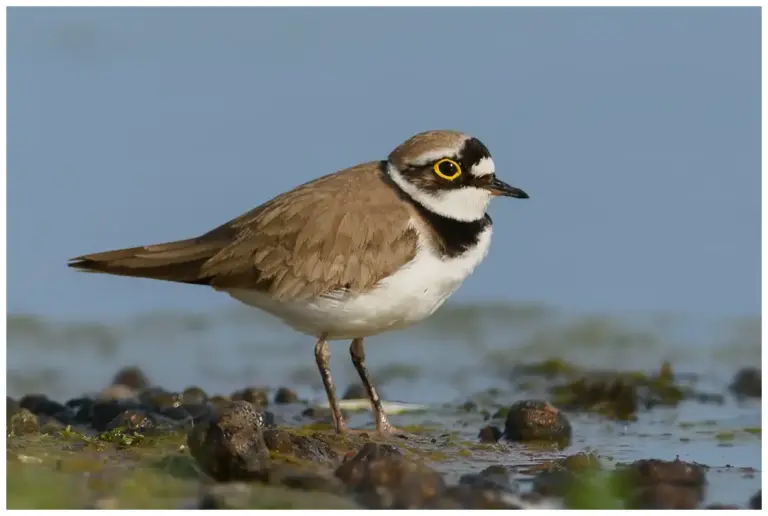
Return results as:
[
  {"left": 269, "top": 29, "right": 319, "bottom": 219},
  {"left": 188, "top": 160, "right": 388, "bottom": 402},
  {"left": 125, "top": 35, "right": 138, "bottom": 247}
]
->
[{"left": 8, "top": 305, "right": 761, "bottom": 505}]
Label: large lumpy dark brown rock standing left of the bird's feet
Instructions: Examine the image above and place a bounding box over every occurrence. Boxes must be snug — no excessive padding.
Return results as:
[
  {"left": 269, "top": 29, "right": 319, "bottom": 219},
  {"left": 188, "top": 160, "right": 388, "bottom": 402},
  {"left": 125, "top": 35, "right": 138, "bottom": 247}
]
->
[{"left": 187, "top": 400, "right": 269, "bottom": 482}]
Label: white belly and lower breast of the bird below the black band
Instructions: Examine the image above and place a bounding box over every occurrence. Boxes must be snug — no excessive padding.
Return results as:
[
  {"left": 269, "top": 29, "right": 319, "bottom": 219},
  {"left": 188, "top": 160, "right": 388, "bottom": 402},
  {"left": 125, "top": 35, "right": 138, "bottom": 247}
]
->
[{"left": 227, "top": 225, "right": 491, "bottom": 339}]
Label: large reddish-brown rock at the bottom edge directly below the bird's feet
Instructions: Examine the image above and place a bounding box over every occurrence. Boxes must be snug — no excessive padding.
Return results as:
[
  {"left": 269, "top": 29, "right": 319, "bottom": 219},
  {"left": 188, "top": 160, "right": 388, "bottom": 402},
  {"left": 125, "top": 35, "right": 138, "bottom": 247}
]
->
[{"left": 336, "top": 443, "right": 445, "bottom": 509}]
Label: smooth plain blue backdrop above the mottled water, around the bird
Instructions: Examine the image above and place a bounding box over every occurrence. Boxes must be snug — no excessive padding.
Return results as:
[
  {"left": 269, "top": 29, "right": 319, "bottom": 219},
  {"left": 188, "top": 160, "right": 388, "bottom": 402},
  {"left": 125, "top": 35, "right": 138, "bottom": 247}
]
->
[{"left": 7, "top": 8, "right": 761, "bottom": 319}]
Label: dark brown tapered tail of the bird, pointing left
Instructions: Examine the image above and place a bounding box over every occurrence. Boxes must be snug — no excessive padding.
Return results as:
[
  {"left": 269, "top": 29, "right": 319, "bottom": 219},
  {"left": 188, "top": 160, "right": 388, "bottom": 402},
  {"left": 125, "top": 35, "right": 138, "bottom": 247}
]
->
[{"left": 68, "top": 239, "right": 223, "bottom": 284}]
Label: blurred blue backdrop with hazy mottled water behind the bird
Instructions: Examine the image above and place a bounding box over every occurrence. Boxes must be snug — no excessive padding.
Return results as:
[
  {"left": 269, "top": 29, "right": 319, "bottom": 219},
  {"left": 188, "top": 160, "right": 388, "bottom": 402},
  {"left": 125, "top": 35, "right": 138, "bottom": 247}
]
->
[{"left": 7, "top": 8, "right": 761, "bottom": 404}]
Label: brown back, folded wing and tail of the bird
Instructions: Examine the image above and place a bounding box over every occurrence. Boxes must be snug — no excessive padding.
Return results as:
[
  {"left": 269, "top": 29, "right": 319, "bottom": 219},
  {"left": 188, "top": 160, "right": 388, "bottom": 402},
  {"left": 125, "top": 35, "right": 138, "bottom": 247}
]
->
[{"left": 70, "top": 162, "right": 417, "bottom": 299}]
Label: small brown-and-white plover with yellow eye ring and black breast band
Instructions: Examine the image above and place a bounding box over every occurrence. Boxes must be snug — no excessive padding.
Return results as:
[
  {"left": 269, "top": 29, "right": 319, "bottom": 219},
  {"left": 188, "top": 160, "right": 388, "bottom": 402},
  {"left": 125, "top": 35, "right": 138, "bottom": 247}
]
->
[{"left": 68, "top": 130, "right": 529, "bottom": 435}]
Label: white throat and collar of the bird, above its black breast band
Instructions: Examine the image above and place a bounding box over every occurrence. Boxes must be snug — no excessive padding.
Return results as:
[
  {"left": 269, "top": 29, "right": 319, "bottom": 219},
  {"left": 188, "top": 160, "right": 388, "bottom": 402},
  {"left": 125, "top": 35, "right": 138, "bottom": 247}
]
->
[{"left": 387, "top": 163, "right": 491, "bottom": 222}]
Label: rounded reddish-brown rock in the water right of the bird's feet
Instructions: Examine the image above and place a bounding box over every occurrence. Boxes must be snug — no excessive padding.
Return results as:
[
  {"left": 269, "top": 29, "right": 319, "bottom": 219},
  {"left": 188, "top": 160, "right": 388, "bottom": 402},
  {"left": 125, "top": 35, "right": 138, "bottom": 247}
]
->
[{"left": 504, "top": 400, "right": 571, "bottom": 444}]
